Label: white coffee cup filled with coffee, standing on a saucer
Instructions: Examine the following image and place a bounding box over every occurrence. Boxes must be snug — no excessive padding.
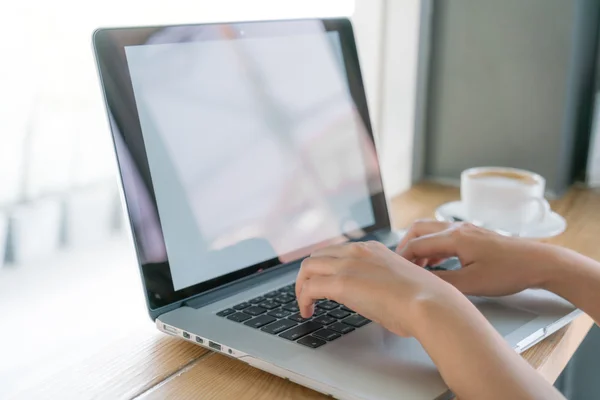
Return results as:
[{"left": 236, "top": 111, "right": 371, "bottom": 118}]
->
[{"left": 460, "top": 167, "right": 550, "bottom": 234}]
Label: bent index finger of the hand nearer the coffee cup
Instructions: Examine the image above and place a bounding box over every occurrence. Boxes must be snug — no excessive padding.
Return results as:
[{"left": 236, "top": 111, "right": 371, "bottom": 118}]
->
[{"left": 398, "top": 231, "right": 457, "bottom": 261}]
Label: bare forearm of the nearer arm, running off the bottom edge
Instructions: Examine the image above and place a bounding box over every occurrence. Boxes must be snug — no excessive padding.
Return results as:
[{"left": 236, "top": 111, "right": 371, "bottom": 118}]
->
[{"left": 415, "top": 292, "right": 563, "bottom": 400}]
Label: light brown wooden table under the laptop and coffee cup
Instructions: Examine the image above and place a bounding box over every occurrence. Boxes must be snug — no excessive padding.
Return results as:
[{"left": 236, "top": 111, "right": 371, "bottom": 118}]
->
[{"left": 11, "top": 184, "right": 600, "bottom": 400}]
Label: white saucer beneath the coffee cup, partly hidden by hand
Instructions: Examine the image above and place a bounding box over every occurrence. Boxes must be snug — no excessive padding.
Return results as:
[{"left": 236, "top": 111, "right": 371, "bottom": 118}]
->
[{"left": 435, "top": 201, "right": 567, "bottom": 239}]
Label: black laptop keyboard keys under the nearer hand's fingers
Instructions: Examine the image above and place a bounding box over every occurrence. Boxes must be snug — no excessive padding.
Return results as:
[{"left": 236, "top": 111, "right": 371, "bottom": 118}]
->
[{"left": 217, "top": 284, "right": 371, "bottom": 349}]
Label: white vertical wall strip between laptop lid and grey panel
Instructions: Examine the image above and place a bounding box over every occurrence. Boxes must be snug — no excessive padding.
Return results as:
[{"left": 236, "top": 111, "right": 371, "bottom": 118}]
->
[{"left": 353, "top": 0, "right": 420, "bottom": 197}]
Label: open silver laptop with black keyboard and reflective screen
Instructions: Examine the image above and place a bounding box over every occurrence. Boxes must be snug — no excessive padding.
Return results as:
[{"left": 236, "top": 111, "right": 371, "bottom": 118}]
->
[{"left": 93, "top": 18, "right": 579, "bottom": 399}]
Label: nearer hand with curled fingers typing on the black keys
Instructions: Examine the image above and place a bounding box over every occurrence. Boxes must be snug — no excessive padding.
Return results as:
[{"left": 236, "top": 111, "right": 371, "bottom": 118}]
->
[{"left": 296, "top": 242, "right": 462, "bottom": 336}]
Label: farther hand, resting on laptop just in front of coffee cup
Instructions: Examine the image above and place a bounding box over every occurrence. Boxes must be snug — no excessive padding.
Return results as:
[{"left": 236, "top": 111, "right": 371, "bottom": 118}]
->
[{"left": 396, "top": 221, "right": 569, "bottom": 296}]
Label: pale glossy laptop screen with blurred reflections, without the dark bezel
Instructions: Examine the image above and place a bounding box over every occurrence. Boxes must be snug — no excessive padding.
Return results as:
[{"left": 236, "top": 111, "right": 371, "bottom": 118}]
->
[{"left": 125, "top": 23, "right": 377, "bottom": 290}]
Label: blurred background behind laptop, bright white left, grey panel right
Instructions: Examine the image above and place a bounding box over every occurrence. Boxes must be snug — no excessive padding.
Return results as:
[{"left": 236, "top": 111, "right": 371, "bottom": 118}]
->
[{"left": 0, "top": 0, "right": 600, "bottom": 399}]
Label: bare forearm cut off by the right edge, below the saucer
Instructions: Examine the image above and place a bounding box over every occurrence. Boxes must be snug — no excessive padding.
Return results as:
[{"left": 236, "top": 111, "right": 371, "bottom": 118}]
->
[{"left": 540, "top": 246, "right": 600, "bottom": 324}]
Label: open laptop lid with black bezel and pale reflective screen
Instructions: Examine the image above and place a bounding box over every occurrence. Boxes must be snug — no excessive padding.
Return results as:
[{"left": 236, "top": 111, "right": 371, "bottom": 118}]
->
[{"left": 93, "top": 19, "right": 390, "bottom": 316}]
